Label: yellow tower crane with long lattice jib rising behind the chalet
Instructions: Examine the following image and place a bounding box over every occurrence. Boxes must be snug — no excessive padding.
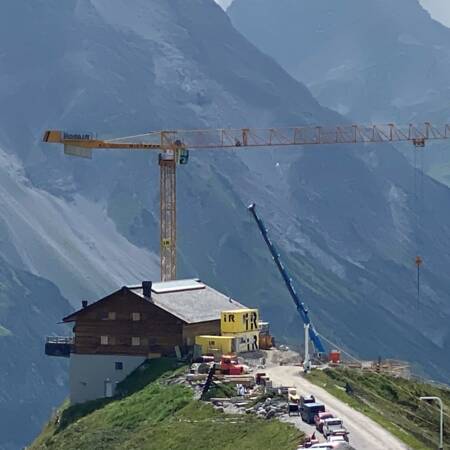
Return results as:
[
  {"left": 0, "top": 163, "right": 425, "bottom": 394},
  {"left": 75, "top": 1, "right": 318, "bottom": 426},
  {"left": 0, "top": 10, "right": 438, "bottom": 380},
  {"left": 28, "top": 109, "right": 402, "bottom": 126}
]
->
[{"left": 43, "top": 122, "right": 450, "bottom": 281}]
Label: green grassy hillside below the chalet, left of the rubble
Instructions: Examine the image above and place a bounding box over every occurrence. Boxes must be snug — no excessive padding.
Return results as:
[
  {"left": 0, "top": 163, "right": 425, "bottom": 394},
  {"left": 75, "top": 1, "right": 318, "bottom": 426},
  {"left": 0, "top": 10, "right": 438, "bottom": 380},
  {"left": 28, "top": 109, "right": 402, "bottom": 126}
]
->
[{"left": 30, "top": 359, "right": 302, "bottom": 450}]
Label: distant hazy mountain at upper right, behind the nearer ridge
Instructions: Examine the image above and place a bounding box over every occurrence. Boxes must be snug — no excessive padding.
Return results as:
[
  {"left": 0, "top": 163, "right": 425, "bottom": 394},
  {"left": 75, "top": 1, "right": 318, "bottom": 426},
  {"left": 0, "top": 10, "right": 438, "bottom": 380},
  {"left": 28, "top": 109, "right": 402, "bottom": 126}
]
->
[{"left": 228, "top": 0, "right": 450, "bottom": 185}]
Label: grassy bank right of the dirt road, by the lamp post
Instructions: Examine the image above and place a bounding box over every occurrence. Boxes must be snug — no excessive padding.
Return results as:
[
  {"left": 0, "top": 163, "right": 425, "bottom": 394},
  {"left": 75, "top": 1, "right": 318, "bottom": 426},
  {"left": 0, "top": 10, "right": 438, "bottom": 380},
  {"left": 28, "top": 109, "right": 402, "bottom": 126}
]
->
[{"left": 307, "top": 369, "right": 450, "bottom": 449}]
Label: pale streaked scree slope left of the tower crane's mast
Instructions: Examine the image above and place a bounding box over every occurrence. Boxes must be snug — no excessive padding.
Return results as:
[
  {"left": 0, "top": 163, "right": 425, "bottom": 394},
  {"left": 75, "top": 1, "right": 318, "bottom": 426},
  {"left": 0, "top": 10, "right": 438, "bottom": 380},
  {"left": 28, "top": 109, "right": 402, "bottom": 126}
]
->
[{"left": 0, "top": 147, "right": 158, "bottom": 306}]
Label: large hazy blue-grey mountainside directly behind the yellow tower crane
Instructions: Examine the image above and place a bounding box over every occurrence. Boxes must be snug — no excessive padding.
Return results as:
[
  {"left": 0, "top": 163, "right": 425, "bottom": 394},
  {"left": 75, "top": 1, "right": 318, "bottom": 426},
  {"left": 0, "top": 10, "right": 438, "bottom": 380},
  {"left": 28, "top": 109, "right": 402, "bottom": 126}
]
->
[{"left": 0, "top": 0, "right": 450, "bottom": 450}]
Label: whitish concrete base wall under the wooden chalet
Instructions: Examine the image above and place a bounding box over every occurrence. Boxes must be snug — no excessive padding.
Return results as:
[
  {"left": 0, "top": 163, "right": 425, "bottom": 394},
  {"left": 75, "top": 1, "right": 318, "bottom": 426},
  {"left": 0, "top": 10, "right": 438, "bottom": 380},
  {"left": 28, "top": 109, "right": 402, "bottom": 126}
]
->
[{"left": 69, "top": 353, "right": 146, "bottom": 404}]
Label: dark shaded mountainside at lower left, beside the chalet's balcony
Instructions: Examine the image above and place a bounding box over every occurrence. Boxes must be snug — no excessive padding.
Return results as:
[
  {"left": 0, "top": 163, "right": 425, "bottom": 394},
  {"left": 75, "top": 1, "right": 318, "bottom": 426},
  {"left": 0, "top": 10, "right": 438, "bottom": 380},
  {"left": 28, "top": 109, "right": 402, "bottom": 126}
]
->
[{"left": 0, "top": 258, "right": 71, "bottom": 450}]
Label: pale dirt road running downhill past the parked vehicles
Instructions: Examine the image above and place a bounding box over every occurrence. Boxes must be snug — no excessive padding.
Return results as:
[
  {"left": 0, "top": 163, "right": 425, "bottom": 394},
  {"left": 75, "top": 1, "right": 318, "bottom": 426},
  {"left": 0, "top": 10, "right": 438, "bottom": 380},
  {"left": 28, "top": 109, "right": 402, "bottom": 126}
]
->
[{"left": 265, "top": 366, "right": 408, "bottom": 450}]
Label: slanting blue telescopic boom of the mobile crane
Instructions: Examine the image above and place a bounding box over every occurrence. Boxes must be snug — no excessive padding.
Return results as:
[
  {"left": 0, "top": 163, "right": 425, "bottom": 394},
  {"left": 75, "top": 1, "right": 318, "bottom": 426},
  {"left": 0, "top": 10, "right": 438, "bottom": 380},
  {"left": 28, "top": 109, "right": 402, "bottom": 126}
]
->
[{"left": 248, "top": 203, "right": 325, "bottom": 353}]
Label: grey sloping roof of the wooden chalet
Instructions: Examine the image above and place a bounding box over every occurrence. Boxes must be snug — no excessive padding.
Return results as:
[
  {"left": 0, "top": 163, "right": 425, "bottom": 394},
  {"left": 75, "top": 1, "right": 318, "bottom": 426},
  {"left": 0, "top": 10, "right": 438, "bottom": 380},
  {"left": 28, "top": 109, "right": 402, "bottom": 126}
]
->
[{"left": 129, "top": 279, "right": 246, "bottom": 323}]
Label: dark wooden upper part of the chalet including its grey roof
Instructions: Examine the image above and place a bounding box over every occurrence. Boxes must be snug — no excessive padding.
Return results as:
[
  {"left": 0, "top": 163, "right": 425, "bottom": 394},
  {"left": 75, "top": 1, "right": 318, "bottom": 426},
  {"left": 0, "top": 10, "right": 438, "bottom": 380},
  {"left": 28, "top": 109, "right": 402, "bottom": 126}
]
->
[{"left": 63, "top": 279, "right": 245, "bottom": 357}]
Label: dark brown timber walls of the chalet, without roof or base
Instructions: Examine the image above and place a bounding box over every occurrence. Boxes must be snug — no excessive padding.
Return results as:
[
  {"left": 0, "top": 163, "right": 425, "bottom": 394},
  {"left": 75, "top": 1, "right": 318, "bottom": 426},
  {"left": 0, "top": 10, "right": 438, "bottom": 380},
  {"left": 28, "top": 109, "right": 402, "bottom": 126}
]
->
[{"left": 64, "top": 288, "right": 220, "bottom": 356}]
